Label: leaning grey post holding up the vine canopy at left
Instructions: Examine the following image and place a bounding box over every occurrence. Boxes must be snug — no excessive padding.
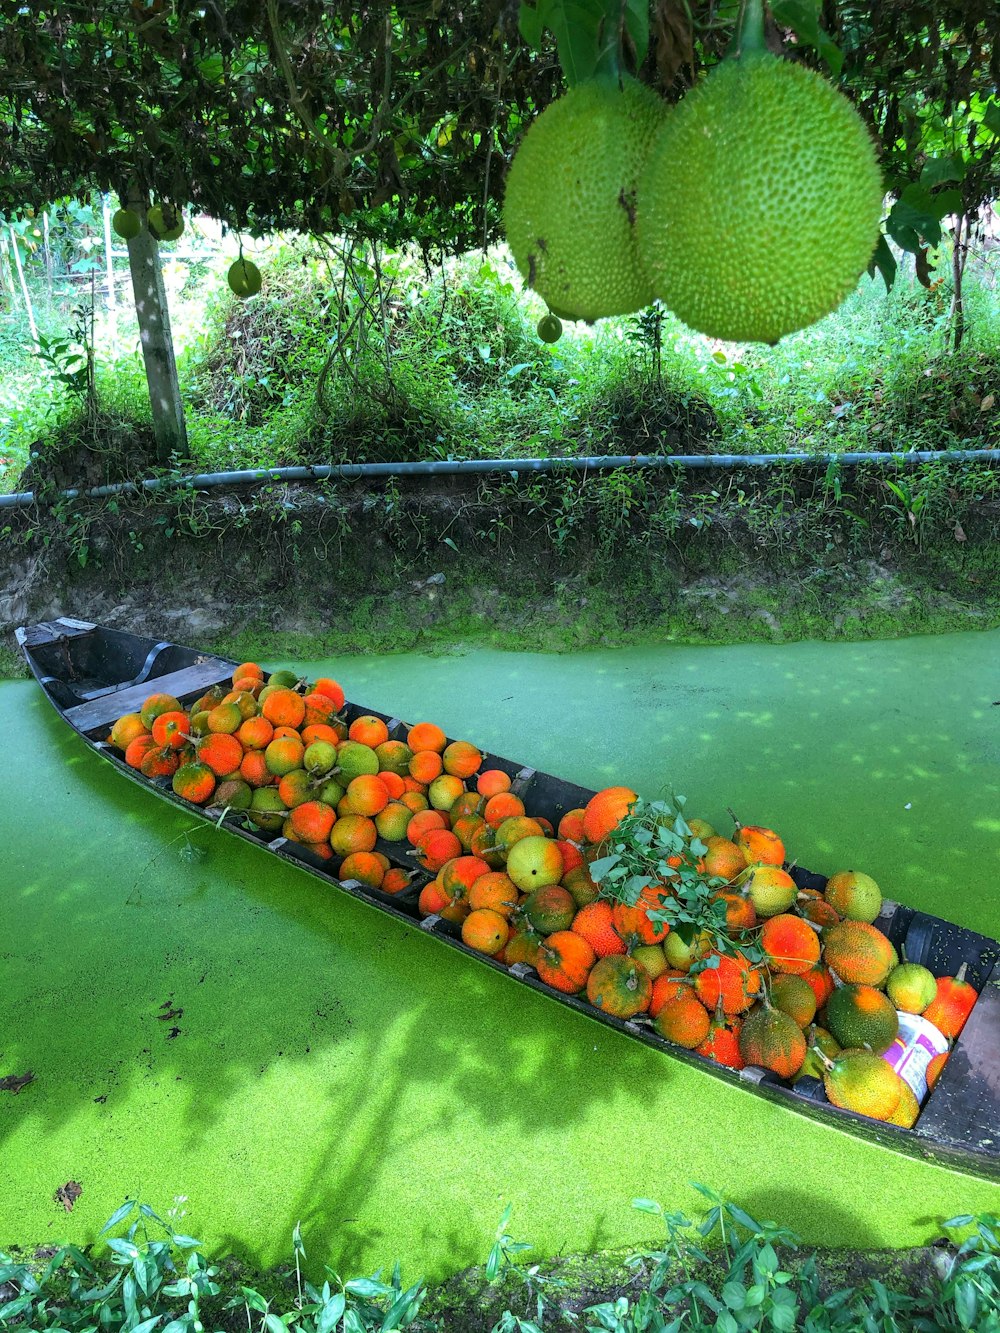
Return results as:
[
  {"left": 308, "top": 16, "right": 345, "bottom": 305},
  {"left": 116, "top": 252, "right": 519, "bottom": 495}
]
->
[{"left": 128, "top": 199, "right": 188, "bottom": 463}]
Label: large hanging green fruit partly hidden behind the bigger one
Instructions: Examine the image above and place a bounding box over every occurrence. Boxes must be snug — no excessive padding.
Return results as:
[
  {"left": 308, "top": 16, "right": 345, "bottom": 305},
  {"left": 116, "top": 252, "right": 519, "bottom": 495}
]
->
[{"left": 504, "top": 81, "right": 667, "bottom": 320}]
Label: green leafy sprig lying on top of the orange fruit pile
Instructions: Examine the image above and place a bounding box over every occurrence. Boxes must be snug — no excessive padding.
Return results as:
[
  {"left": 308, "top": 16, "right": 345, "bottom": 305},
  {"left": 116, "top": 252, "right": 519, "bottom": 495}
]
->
[{"left": 589, "top": 796, "right": 764, "bottom": 972}]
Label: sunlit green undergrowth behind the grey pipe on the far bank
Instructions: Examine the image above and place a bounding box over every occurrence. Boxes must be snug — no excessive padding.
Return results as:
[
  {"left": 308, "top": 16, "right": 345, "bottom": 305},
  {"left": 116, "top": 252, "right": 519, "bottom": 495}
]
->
[{"left": 0, "top": 223, "right": 1000, "bottom": 491}]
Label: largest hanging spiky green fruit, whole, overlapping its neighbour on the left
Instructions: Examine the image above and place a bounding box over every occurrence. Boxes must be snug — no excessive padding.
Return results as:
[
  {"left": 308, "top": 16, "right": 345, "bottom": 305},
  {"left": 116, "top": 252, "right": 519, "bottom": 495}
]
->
[{"left": 636, "top": 53, "right": 883, "bottom": 343}]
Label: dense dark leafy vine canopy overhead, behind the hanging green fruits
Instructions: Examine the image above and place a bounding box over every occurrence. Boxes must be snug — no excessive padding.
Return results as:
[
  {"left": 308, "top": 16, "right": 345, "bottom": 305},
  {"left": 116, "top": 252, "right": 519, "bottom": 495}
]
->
[{"left": 0, "top": 0, "right": 1000, "bottom": 257}]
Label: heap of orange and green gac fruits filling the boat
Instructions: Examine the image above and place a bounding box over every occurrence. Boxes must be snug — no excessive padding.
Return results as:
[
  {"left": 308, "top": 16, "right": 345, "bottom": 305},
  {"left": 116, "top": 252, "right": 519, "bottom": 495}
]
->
[{"left": 109, "top": 663, "right": 976, "bottom": 1125}]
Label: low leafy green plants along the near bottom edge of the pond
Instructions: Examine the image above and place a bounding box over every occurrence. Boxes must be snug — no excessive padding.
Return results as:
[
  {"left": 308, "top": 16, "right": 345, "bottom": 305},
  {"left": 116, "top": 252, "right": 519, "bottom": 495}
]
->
[{"left": 0, "top": 1182, "right": 1000, "bottom": 1333}]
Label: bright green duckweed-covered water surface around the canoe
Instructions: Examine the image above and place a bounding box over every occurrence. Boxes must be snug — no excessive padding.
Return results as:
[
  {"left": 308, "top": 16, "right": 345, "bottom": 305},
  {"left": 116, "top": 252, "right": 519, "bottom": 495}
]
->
[{"left": 0, "top": 632, "right": 1000, "bottom": 1277}]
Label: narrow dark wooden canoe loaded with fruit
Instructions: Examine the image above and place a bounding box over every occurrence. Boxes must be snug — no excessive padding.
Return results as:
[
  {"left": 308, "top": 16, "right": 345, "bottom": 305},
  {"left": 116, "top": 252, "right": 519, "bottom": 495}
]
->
[{"left": 17, "top": 619, "right": 1000, "bottom": 1180}]
